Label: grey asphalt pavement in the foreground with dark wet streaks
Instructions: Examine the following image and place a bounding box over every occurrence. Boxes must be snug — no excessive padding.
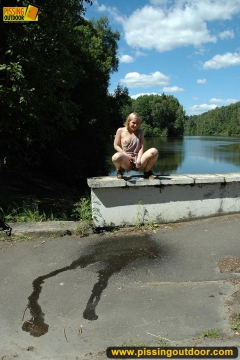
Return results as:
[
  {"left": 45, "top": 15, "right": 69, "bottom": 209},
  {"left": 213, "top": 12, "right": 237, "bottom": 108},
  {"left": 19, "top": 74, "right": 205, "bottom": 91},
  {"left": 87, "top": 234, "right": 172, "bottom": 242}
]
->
[{"left": 0, "top": 214, "right": 240, "bottom": 360}]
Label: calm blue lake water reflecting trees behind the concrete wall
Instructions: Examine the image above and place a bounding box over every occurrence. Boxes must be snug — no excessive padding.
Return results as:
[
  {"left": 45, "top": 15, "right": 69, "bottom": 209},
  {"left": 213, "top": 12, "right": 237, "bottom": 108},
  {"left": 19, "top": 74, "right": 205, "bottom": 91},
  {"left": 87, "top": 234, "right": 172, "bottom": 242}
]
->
[{"left": 109, "top": 136, "right": 240, "bottom": 176}]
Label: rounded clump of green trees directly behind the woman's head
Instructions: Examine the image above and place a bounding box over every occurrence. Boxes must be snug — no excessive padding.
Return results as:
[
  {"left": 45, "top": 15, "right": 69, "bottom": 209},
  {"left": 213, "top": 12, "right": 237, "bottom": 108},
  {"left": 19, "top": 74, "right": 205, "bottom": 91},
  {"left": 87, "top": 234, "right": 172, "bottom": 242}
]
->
[{"left": 123, "top": 94, "right": 186, "bottom": 136}]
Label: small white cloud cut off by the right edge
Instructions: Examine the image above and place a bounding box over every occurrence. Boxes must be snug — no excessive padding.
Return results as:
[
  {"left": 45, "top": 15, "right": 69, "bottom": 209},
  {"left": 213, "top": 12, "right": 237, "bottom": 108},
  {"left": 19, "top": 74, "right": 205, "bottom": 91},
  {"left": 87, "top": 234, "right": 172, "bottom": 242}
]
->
[{"left": 203, "top": 53, "right": 240, "bottom": 70}]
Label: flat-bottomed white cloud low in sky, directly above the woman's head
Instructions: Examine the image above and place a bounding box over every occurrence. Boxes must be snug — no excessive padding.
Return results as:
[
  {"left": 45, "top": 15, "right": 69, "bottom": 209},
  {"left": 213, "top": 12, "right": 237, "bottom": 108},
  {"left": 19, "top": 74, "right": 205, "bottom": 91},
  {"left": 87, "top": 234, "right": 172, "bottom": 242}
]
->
[{"left": 119, "top": 71, "right": 169, "bottom": 88}]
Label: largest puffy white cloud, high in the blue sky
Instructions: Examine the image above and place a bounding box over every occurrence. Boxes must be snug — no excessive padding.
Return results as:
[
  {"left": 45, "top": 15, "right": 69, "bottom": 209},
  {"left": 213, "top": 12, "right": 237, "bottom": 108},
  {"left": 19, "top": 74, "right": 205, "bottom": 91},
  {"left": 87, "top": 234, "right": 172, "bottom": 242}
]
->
[{"left": 123, "top": 4, "right": 217, "bottom": 52}]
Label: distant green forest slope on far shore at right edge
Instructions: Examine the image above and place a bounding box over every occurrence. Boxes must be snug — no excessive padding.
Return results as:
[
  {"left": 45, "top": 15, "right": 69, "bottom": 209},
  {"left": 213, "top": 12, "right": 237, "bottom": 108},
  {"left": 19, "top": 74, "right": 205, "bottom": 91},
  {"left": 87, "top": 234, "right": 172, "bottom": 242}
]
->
[{"left": 185, "top": 102, "right": 240, "bottom": 136}]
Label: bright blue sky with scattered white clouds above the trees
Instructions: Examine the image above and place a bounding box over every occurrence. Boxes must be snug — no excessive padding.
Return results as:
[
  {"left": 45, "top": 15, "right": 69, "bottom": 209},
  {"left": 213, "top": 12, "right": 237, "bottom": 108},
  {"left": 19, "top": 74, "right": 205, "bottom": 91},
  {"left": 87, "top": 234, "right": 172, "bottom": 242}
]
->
[{"left": 83, "top": 0, "right": 240, "bottom": 115}]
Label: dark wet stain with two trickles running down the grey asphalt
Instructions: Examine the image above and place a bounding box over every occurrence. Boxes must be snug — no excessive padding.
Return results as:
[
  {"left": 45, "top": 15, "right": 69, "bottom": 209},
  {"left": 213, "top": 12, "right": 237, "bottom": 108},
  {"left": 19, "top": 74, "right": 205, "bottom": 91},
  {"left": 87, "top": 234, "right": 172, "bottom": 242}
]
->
[{"left": 22, "top": 235, "right": 160, "bottom": 337}]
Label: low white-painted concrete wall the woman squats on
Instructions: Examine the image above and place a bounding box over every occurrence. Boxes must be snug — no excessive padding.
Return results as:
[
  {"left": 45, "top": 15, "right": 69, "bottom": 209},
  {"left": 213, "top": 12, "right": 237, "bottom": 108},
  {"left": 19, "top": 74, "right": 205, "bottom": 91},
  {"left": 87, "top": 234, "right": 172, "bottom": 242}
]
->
[{"left": 88, "top": 173, "right": 240, "bottom": 227}]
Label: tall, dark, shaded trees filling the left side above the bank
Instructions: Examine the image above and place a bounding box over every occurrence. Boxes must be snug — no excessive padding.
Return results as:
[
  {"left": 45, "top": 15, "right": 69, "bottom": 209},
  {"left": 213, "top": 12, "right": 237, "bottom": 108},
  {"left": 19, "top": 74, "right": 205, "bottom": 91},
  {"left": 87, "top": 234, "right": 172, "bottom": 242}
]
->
[{"left": 0, "top": 0, "right": 130, "bottom": 182}]
